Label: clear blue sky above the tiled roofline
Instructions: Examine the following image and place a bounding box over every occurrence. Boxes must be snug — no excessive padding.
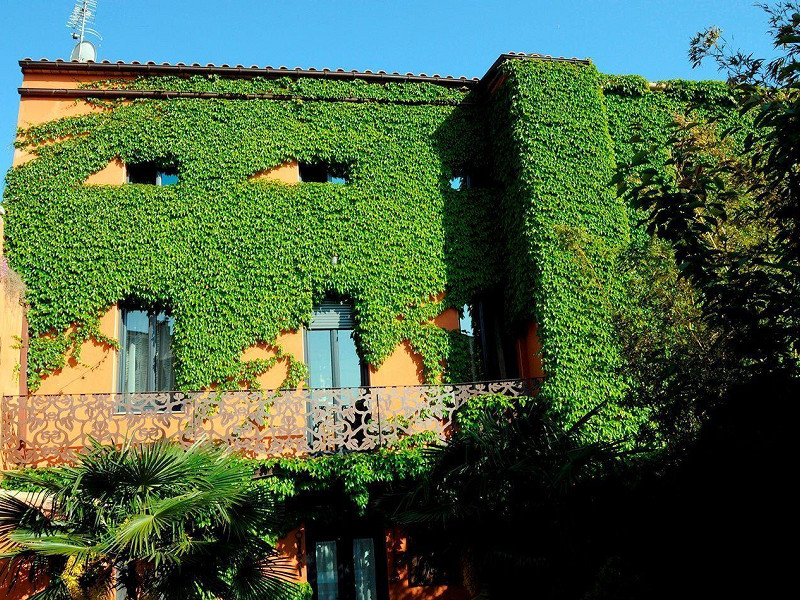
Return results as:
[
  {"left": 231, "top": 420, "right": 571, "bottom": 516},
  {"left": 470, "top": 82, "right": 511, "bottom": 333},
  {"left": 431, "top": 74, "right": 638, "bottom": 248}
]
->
[{"left": 0, "top": 0, "right": 771, "bottom": 185}]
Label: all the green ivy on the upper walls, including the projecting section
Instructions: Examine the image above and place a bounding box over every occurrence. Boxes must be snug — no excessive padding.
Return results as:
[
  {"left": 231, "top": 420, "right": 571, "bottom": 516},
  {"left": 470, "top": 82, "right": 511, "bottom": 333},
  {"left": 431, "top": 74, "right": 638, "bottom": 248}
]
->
[{"left": 5, "top": 60, "right": 748, "bottom": 446}]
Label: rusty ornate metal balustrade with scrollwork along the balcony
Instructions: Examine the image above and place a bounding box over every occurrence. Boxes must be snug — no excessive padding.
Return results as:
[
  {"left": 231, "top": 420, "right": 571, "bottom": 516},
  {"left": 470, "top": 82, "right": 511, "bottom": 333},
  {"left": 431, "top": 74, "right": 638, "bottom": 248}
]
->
[{"left": 0, "top": 380, "right": 538, "bottom": 468}]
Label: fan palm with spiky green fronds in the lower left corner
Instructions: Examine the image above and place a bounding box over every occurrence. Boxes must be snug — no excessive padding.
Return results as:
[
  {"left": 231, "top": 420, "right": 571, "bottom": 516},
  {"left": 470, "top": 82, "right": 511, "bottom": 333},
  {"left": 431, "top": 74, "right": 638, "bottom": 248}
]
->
[{"left": 0, "top": 441, "right": 294, "bottom": 600}]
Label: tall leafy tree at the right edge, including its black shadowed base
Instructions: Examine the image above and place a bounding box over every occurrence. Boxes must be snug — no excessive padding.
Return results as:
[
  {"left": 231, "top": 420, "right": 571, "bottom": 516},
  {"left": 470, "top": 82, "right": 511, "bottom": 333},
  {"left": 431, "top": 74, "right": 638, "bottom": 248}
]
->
[{"left": 600, "top": 2, "right": 800, "bottom": 598}]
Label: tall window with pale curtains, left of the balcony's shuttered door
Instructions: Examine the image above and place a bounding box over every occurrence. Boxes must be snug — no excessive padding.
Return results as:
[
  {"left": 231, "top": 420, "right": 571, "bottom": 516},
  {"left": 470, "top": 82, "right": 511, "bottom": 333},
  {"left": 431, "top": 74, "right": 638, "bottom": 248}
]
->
[{"left": 119, "top": 308, "right": 175, "bottom": 393}]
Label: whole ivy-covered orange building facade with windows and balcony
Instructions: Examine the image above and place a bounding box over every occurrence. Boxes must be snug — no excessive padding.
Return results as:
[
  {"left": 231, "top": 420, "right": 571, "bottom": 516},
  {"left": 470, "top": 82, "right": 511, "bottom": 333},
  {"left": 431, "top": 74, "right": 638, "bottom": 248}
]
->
[{"left": 0, "top": 54, "right": 740, "bottom": 600}]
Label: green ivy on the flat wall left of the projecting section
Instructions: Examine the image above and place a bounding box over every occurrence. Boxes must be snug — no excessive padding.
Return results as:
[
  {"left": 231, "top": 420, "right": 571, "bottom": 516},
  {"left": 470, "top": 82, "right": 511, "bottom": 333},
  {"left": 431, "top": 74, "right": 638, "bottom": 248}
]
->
[{"left": 5, "top": 77, "right": 497, "bottom": 389}]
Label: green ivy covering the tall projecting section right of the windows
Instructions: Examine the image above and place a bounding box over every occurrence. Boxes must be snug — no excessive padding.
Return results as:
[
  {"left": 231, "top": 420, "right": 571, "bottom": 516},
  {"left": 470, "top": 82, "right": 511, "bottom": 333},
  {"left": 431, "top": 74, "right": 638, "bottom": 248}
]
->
[{"left": 491, "top": 61, "right": 637, "bottom": 435}]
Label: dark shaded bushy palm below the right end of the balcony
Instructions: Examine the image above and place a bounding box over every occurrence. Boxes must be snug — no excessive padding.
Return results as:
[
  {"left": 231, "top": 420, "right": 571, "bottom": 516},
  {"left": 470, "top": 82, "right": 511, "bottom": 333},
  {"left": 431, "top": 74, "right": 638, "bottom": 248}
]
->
[{"left": 390, "top": 396, "right": 632, "bottom": 598}]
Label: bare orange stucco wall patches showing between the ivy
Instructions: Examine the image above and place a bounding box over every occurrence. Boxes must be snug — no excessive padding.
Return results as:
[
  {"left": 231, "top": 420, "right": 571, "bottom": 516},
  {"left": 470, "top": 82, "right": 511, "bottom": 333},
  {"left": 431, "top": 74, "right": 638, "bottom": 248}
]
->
[{"left": 0, "top": 69, "right": 488, "bottom": 600}]
